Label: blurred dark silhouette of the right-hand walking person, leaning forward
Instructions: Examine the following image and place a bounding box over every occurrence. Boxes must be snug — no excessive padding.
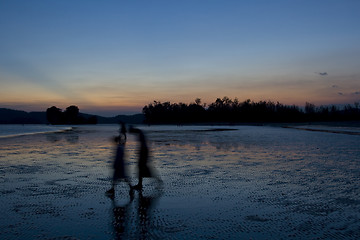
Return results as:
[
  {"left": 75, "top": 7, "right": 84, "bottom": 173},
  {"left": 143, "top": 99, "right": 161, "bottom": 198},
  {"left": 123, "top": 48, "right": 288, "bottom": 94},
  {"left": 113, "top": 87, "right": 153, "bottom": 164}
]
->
[{"left": 129, "top": 127, "right": 162, "bottom": 190}]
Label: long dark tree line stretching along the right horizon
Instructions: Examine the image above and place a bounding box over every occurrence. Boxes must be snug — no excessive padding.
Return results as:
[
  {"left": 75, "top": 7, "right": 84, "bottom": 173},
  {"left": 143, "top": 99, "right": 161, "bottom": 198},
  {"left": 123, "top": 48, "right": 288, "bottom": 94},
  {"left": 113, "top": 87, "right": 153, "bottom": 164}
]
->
[{"left": 142, "top": 97, "right": 360, "bottom": 124}]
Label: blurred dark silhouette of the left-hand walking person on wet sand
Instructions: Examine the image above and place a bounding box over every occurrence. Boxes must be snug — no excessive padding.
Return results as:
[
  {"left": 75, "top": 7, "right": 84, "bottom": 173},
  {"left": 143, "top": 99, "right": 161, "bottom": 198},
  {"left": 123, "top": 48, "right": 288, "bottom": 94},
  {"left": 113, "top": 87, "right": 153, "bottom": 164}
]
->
[{"left": 106, "top": 123, "right": 131, "bottom": 197}]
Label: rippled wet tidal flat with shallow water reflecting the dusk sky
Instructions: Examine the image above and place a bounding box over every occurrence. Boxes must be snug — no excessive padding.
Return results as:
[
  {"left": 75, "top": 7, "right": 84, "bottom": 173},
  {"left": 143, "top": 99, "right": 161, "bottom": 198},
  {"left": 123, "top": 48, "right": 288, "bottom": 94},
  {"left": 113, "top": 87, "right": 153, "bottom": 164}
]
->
[{"left": 0, "top": 125, "right": 360, "bottom": 239}]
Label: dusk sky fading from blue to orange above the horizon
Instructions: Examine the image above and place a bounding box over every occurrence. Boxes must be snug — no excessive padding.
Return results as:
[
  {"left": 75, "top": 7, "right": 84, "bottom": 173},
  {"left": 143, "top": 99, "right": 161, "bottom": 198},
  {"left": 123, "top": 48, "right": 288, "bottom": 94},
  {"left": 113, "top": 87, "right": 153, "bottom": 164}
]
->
[{"left": 0, "top": 0, "right": 360, "bottom": 116}]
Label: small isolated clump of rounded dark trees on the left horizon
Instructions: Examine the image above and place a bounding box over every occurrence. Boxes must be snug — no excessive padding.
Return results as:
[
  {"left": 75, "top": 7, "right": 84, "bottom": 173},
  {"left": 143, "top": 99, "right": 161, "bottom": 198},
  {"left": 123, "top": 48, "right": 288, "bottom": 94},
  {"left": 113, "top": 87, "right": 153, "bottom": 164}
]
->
[{"left": 46, "top": 105, "right": 97, "bottom": 125}]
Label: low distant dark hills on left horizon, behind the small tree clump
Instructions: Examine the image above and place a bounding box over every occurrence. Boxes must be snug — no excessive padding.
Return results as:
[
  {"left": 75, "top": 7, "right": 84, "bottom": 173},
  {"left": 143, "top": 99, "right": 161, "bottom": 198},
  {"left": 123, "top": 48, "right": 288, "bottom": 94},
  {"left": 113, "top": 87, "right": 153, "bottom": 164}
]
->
[{"left": 0, "top": 106, "right": 144, "bottom": 124}]
